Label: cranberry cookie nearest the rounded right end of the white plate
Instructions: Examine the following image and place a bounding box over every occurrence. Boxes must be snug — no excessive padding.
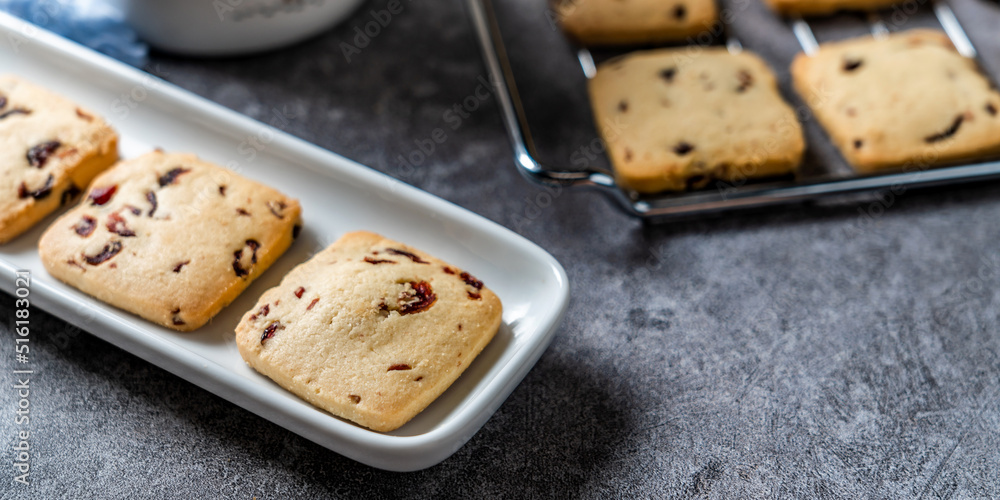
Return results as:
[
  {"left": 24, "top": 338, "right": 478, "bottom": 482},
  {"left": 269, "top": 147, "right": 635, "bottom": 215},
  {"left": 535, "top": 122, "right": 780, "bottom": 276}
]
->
[{"left": 236, "top": 232, "right": 502, "bottom": 431}]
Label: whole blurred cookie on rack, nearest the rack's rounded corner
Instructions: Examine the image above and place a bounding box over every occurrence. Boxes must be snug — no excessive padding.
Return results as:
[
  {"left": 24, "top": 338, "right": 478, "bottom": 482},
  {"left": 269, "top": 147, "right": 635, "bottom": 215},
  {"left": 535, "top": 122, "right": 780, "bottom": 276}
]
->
[{"left": 590, "top": 49, "right": 805, "bottom": 193}]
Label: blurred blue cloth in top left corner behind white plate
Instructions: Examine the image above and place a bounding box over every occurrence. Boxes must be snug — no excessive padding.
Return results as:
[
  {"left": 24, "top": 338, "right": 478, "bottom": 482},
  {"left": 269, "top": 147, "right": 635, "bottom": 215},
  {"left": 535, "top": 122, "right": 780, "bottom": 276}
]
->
[{"left": 0, "top": 0, "right": 149, "bottom": 68}]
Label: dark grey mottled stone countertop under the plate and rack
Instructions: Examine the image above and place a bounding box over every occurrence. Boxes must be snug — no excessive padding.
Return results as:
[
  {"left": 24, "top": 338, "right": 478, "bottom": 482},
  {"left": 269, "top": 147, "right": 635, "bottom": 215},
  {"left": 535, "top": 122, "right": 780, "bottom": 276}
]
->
[{"left": 0, "top": 0, "right": 1000, "bottom": 499}]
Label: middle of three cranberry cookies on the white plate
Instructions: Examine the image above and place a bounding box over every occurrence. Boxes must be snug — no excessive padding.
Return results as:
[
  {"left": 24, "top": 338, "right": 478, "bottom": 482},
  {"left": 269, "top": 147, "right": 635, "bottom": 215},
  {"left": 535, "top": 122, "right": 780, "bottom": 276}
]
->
[{"left": 39, "top": 152, "right": 301, "bottom": 331}]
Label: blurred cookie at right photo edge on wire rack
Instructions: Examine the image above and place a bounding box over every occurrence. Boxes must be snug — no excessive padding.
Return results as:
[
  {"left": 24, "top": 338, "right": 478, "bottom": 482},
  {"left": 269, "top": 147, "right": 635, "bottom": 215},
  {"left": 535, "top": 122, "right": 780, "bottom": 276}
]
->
[{"left": 792, "top": 30, "right": 1000, "bottom": 172}]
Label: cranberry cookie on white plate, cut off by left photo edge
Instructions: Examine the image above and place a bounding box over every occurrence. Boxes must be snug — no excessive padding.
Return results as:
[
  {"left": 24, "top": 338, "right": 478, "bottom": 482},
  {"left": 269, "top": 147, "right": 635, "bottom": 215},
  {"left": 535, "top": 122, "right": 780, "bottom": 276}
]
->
[{"left": 0, "top": 75, "right": 118, "bottom": 243}]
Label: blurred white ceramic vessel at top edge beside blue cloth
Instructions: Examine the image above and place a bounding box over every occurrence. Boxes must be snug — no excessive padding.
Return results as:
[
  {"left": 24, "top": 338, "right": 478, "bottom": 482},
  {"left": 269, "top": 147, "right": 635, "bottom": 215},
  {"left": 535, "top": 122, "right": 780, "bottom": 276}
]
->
[{"left": 115, "top": 0, "right": 364, "bottom": 56}]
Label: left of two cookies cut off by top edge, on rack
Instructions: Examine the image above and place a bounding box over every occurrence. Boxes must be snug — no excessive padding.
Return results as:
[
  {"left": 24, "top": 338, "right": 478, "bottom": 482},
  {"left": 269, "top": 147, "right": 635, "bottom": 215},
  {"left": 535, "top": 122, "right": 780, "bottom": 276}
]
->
[{"left": 553, "top": 0, "right": 719, "bottom": 45}]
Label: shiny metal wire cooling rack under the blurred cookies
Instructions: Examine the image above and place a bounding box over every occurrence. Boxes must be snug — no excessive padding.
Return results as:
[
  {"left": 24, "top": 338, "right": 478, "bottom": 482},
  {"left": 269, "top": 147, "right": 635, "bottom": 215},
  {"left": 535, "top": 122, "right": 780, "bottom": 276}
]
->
[{"left": 467, "top": 0, "right": 1000, "bottom": 222}]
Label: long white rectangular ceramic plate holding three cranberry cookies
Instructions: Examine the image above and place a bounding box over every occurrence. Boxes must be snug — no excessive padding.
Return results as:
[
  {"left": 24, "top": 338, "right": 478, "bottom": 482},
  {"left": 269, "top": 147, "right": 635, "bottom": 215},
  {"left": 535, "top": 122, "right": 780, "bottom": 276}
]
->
[{"left": 0, "top": 13, "right": 569, "bottom": 471}]
